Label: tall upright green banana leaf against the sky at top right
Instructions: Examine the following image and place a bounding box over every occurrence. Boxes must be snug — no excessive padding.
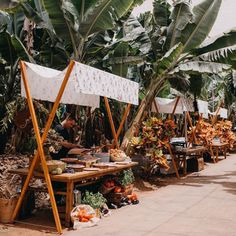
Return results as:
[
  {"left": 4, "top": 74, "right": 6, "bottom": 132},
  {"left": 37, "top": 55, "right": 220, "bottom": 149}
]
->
[{"left": 181, "top": 0, "right": 222, "bottom": 52}]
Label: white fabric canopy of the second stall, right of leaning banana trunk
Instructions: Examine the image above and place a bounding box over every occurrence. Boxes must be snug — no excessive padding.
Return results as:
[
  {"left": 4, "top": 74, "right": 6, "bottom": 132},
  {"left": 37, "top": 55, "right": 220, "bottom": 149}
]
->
[{"left": 152, "top": 97, "right": 193, "bottom": 114}]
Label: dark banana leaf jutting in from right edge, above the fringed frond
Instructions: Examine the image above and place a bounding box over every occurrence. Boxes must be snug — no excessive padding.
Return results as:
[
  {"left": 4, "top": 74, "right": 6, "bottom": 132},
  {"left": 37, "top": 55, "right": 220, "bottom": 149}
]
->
[{"left": 194, "top": 28, "right": 236, "bottom": 55}]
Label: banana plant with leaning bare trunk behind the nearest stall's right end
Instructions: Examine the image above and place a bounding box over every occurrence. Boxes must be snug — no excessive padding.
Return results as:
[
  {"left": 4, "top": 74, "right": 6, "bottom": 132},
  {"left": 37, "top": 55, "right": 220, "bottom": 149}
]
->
[{"left": 122, "top": 0, "right": 234, "bottom": 152}]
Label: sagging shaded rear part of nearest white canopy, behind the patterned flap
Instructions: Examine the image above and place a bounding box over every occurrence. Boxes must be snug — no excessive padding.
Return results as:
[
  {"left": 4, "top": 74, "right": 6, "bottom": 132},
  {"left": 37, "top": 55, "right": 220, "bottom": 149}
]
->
[{"left": 21, "top": 62, "right": 100, "bottom": 108}]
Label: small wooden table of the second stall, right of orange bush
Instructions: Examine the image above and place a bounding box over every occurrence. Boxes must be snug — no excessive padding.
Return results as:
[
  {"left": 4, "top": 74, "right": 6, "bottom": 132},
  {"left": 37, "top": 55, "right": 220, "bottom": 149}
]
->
[{"left": 173, "top": 146, "right": 207, "bottom": 176}]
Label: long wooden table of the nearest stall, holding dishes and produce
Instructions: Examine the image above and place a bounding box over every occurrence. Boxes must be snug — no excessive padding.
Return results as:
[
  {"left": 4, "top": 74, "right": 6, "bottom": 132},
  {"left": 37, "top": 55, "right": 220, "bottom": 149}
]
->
[{"left": 9, "top": 162, "right": 138, "bottom": 227}]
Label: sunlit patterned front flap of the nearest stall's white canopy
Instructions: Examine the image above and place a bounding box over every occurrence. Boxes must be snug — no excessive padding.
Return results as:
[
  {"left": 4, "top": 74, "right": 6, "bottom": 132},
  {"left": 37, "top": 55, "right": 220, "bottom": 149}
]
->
[{"left": 74, "top": 62, "right": 139, "bottom": 105}]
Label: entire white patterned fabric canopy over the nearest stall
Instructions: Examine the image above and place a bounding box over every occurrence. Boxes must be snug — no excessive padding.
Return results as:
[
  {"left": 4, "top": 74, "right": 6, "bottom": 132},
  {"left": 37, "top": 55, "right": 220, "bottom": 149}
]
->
[{"left": 21, "top": 62, "right": 139, "bottom": 107}]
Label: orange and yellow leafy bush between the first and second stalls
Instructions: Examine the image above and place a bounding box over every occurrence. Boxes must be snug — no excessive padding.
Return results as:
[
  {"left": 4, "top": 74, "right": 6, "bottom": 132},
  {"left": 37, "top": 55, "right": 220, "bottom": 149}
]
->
[{"left": 131, "top": 117, "right": 176, "bottom": 171}]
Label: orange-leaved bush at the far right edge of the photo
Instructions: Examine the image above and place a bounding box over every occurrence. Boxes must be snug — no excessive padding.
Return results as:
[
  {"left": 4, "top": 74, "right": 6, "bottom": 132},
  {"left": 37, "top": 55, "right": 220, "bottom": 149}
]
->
[{"left": 215, "top": 120, "right": 236, "bottom": 148}]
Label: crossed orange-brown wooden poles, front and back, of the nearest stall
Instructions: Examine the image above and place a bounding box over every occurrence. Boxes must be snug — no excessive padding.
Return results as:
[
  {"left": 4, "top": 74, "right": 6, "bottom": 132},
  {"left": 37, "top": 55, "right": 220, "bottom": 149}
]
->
[{"left": 11, "top": 61, "right": 131, "bottom": 234}]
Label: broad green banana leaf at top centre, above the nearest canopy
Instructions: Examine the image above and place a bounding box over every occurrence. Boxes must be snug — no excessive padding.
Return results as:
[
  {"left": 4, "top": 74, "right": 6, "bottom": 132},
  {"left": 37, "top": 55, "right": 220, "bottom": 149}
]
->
[{"left": 79, "top": 0, "right": 134, "bottom": 39}]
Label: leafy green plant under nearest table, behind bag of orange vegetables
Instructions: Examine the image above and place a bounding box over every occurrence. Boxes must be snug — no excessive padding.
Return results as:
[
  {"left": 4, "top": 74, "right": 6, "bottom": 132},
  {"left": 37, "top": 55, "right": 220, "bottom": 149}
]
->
[{"left": 82, "top": 191, "right": 107, "bottom": 217}]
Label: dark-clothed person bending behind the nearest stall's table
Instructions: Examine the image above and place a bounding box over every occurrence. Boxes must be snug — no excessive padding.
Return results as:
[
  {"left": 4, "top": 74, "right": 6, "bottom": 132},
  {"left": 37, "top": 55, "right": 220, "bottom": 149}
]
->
[{"left": 51, "top": 115, "right": 79, "bottom": 160}]
